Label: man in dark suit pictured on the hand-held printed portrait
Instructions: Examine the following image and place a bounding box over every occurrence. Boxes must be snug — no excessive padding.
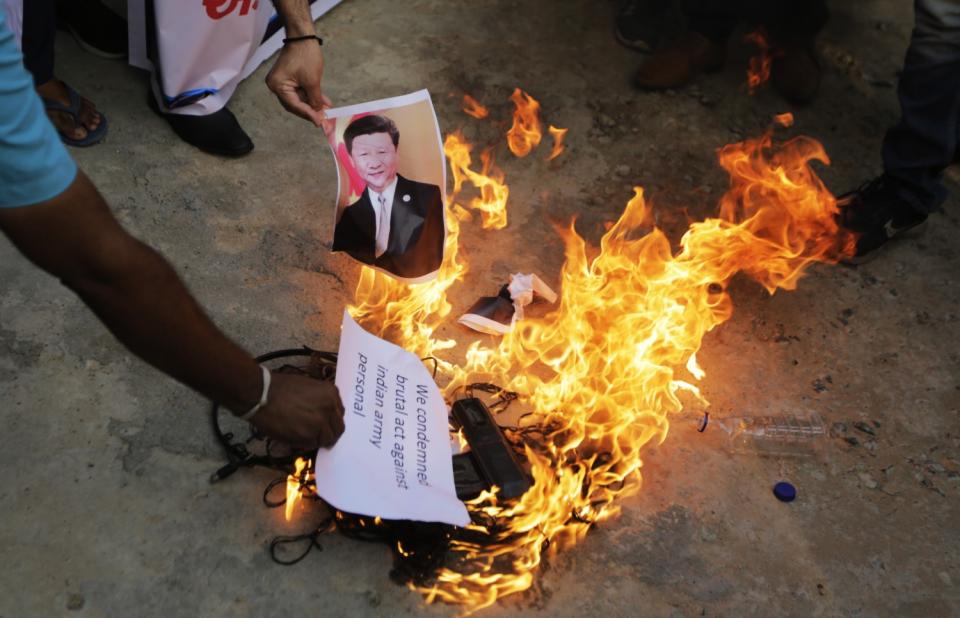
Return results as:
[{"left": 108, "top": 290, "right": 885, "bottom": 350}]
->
[{"left": 333, "top": 115, "right": 445, "bottom": 279}]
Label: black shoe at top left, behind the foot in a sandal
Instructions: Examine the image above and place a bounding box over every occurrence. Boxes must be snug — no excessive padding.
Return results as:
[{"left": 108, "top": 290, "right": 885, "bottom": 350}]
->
[{"left": 56, "top": 0, "right": 127, "bottom": 59}]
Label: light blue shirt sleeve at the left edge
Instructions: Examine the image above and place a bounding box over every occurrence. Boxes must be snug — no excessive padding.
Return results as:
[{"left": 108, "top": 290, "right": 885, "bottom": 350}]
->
[{"left": 0, "top": 9, "right": 77, "bottom": 208}]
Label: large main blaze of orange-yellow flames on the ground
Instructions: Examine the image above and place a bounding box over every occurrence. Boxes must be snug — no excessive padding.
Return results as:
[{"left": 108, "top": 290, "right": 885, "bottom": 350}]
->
[{"left": 344, "top": 102, "right": 854, "bottom": 609}]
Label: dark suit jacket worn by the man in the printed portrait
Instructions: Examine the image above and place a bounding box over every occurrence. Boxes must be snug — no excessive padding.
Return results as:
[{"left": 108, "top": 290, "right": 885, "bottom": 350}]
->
[{"left": 333, "top": 174, "right": 446, "bottom": 279}]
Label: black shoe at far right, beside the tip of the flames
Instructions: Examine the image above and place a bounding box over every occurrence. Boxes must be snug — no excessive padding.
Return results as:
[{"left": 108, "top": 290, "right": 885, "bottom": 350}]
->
[{"left": 837, "top": 176, "right": 927, "bottom": 264}]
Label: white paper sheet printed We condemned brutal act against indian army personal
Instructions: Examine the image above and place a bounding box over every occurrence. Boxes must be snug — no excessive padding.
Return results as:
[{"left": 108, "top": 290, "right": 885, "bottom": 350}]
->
[{"left": 316, "top": 311, "right": 470, "bottom": 526}]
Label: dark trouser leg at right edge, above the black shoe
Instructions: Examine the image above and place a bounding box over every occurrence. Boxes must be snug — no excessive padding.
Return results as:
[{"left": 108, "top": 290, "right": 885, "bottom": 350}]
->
[{"left": 883, "top": 0, "right": 960, "bottom": 213}]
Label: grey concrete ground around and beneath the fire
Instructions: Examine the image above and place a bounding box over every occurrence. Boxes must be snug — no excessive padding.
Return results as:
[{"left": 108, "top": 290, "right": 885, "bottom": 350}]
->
[{"left": 0, "top": 0, "right": 960, "bottom": 618}]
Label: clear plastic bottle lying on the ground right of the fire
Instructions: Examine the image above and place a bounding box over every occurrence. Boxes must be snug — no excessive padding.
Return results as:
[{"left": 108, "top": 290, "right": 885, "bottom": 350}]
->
[{"left": 710, "top": 412, "right": 827, "bottom": 457}]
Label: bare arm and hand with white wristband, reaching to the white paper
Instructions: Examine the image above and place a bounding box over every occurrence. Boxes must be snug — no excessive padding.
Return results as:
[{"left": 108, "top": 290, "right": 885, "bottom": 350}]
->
[{"left": 0, "top": 172, "right": 343, "bottom": 446}]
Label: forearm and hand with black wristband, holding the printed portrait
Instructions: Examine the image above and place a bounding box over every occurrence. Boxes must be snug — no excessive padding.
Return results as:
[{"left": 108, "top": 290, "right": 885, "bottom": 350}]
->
[{"left": 267, "top": 0, "right": 332, "bottom": 127}]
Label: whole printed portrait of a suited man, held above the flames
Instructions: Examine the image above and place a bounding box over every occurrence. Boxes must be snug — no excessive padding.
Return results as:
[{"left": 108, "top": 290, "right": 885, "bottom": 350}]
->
[{"left": 326, "top": 90, "right": 447, "bottom": 283}]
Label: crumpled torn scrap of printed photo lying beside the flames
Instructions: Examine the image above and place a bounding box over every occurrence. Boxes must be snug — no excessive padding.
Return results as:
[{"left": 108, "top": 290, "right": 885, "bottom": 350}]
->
[{"left": 457, "top": 274, "right": 557, "bottom": 335}]
